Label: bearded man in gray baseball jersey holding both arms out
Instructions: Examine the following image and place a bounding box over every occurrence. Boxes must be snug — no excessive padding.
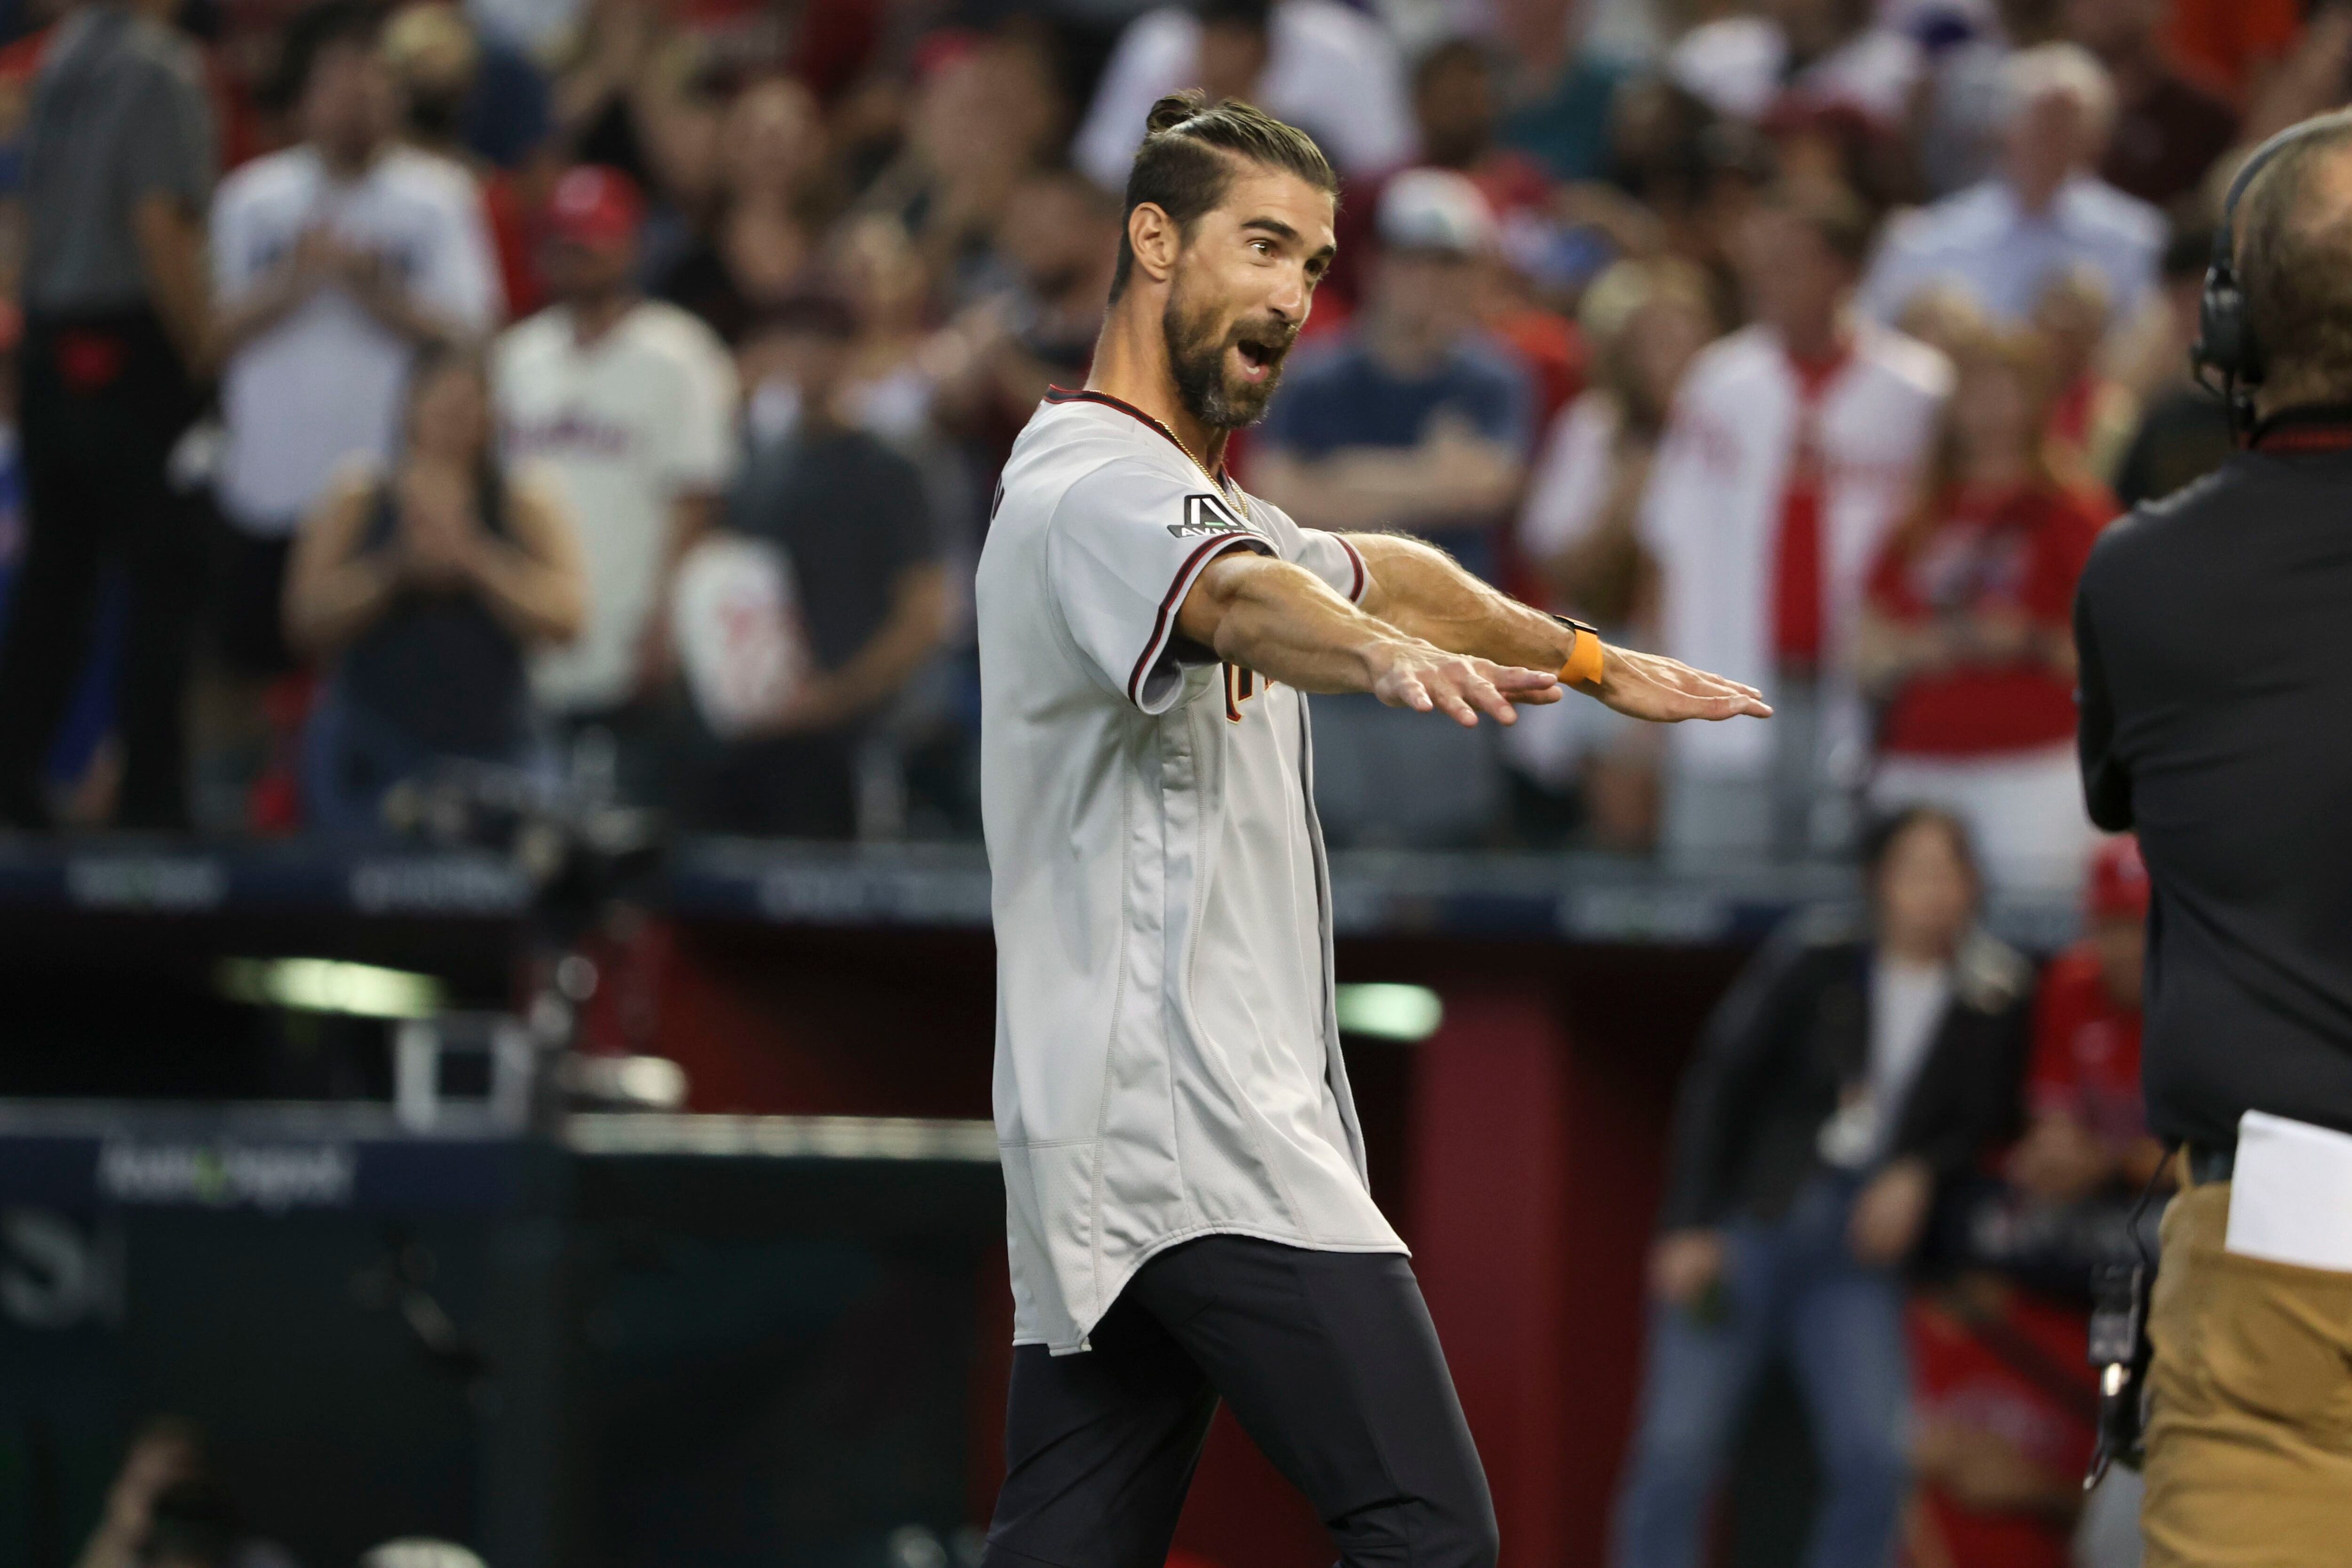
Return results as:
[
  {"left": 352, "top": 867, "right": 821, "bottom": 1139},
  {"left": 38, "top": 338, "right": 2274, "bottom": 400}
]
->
[{"left": 976, "top": 94, "right": 1769, "bottom": 1568}]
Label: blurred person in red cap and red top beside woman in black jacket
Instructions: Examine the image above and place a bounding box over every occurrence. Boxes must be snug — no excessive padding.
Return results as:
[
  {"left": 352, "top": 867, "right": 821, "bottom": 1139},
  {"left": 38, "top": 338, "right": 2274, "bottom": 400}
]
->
[{"left": 2009, "top": 832, "right": 2164, "bottom": 1201}]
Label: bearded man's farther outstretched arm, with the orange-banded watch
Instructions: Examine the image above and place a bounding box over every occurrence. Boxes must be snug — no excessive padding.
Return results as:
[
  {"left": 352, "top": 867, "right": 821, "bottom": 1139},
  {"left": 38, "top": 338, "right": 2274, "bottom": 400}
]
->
[{"left": 1348, "top": 533, "right": 1771, "bottom": 724}]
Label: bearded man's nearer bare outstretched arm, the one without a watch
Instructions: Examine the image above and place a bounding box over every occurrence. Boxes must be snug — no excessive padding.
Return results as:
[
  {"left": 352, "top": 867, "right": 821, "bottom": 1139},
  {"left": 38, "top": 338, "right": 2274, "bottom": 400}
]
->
[{"left": 1176, "top": 550, "right": 1559, "bottom": 724}]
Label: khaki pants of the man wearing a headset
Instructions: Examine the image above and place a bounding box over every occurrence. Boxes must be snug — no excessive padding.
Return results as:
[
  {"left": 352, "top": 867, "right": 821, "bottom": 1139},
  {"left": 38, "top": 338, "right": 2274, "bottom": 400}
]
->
[{"left": 2140, "top": 1182, "right": 2352, "bottom": 1568}]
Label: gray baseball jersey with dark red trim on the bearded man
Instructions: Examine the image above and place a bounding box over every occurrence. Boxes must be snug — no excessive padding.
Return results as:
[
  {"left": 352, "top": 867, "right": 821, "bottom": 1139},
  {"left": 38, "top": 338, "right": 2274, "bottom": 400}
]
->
[{"left": 978, "top": 390, "right": 1404, "bottom": 1354}]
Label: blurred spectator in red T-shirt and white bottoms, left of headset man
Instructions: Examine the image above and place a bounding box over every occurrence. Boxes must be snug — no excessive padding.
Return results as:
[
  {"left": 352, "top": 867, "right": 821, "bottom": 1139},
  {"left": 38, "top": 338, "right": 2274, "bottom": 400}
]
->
[{"left": 1853, "top": 336, "right": 2112, "bottom": 891}]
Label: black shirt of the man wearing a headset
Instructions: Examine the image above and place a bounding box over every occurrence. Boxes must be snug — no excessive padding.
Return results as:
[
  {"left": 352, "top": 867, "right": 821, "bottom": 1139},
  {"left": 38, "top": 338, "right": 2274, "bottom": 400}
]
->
[{"left": 2074, "top": 409, "right": 2352, "bottom": 1145}]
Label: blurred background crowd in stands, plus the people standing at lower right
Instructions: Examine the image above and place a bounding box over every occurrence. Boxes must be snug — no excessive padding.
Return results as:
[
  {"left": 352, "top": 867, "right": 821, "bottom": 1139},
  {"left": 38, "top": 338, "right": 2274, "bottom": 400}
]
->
[{"left": 0, "top": 0, "right": 2324, "bottom": 1568}]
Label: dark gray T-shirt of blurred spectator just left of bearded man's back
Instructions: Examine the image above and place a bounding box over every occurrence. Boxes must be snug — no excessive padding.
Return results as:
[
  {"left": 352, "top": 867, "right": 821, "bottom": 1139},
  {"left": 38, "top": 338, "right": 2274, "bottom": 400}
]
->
[{"left": 727, "top": 430, "right": 938, "bottom": 670}]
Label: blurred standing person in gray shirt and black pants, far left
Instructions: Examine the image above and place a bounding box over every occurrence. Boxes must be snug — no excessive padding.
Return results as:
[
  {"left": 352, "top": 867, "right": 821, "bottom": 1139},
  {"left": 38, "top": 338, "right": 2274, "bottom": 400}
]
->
[{"left": 0, "top": 0, "right": 214, "bottom": 828}]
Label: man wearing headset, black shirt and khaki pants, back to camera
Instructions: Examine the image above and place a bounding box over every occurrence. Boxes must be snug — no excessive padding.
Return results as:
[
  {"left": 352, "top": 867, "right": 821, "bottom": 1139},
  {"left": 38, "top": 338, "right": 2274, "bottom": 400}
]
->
[{"left": 2074, "top": 115, "right": 2352, "bottom": 1568}]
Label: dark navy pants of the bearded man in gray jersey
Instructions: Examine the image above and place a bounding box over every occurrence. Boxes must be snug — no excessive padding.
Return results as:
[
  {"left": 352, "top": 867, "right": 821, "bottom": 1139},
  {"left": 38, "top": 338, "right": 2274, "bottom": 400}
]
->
[{"left": 983, "top": 1236, "right": 1496, "bottom": 1568}]
